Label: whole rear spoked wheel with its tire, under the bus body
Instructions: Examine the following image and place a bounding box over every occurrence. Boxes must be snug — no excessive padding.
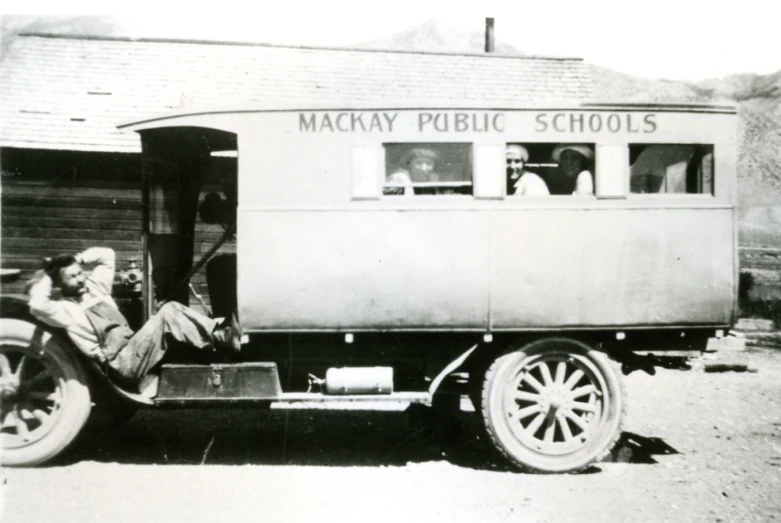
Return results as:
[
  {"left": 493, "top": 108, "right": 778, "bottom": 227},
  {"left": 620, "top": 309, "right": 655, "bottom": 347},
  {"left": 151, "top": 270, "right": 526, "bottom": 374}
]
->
[{"left": 482, "top": 338, "right": 624, "bottom": 473}]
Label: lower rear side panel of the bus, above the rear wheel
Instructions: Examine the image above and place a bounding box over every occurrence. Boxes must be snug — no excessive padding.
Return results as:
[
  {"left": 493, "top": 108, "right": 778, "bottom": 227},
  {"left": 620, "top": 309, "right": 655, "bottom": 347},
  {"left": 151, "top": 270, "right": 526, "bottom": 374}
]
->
[{"left": 492, "top": 208, "right": 734, "bottom": 329}]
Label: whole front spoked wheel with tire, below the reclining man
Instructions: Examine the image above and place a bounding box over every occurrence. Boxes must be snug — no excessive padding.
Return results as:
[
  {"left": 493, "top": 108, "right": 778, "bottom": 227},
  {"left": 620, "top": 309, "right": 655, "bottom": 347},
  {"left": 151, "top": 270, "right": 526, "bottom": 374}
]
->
[{"left": 0, "top": 319, "right": 91, "bottom": 466}]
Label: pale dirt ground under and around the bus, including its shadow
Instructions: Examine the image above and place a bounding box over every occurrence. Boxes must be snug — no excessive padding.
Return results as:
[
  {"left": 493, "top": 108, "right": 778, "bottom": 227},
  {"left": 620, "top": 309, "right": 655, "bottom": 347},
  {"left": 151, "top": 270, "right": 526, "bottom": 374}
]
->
[{"left": 0, "top": 350, "right": 781, "bottom": 523}]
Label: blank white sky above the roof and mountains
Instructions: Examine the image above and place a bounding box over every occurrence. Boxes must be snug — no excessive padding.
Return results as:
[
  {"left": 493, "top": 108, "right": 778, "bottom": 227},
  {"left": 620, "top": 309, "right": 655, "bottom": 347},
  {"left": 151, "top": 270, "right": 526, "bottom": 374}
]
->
[{"left": 2, "top": 0, "right": 781, "bottom": 80}]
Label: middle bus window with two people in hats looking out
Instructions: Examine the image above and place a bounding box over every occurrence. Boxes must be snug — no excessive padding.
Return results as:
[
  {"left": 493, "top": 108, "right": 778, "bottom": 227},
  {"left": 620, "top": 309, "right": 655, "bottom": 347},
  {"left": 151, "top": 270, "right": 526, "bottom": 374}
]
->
[{"left": 506, "top": 143, "right": 595, "bottom": 196}]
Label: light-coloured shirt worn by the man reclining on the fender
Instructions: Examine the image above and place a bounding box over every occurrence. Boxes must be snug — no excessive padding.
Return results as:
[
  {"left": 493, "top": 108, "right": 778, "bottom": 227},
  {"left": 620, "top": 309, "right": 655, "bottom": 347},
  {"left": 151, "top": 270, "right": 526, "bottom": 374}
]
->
[{"left": 29, "top": 247, "right": 117, "bottom": 355}]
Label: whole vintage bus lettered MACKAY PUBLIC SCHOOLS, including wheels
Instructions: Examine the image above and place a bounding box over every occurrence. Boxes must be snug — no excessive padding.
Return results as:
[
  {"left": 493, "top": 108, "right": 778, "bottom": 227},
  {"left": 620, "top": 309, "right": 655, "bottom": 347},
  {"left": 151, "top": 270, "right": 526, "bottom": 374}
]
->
[{"left": 0, "top": 104, "right": 738, "bottom": 472}]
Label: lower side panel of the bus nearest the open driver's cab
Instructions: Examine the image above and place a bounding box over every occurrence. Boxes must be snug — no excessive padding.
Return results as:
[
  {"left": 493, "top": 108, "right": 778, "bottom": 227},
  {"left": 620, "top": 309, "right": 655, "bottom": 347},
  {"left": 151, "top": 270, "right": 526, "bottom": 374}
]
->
[{"left": 238, "top": 210, "right": 490, "bottom": 330}]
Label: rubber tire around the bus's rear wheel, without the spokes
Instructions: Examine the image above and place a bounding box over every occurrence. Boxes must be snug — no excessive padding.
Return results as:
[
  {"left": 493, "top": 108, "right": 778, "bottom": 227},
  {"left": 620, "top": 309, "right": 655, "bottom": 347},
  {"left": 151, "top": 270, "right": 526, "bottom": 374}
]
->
[{"left": 481, "top": 338, "right": 626, "bottom": 474}]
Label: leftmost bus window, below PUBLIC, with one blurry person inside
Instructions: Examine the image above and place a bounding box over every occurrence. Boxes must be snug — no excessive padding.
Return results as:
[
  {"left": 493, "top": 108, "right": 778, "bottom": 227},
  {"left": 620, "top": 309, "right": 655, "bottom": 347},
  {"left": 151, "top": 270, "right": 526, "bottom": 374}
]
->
[{"left": 383, "top": 143, "right": 472, "bottom": 196}]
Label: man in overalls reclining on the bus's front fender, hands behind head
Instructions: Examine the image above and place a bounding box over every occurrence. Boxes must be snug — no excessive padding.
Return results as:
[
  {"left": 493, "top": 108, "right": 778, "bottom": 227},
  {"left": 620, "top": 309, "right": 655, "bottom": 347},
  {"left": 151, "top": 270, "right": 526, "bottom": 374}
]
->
[{"left": 29, "top": 247, "right": 241, "bottom": 397}]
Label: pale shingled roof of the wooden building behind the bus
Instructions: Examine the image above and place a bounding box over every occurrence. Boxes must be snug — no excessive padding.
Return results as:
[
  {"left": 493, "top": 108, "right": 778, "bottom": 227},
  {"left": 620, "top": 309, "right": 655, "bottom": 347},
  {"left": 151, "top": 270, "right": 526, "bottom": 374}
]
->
[{"left": 0, "top": 35, "right": 593, "bottom": 152}]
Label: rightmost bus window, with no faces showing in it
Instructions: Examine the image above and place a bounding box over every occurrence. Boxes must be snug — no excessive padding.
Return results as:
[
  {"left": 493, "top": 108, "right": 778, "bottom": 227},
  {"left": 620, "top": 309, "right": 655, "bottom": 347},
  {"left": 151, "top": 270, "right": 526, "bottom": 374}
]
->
[{"left": 629, "top": 144, "right": 713, "bottom": 195}]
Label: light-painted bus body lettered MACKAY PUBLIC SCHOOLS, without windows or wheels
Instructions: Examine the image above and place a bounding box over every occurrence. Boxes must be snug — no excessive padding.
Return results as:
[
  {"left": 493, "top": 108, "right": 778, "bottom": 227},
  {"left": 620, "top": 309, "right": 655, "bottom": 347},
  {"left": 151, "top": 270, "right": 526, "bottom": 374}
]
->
[{"left": 122, "top": 106, "right": 737, "bottom": 332}]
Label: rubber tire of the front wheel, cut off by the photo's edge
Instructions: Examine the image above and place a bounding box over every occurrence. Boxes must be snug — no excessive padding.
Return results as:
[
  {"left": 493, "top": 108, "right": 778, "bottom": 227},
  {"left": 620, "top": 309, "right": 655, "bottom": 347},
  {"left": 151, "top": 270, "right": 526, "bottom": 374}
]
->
[{"left": 0, "top": 318, "right": 92, "bottom": 467}]
